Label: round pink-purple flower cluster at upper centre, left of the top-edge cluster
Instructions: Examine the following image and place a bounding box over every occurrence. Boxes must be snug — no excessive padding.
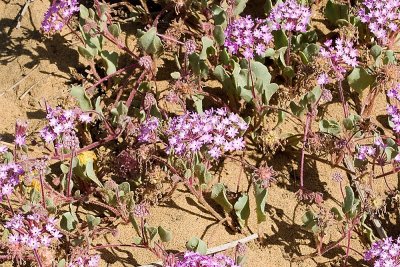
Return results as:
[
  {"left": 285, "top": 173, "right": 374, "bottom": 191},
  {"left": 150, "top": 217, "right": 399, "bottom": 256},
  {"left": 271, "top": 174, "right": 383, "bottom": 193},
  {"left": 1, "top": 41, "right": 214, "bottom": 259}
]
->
[{"left": 225, "top": 16, "right": 273, "bottom": 59}]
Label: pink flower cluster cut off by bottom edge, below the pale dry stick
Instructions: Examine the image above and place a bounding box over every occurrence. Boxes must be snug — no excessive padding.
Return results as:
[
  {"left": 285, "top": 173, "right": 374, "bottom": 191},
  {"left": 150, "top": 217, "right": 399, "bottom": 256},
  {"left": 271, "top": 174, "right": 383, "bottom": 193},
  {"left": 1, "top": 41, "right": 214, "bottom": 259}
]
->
[{"left": 174, "top": 251, "right": 239, "bottom": 267}]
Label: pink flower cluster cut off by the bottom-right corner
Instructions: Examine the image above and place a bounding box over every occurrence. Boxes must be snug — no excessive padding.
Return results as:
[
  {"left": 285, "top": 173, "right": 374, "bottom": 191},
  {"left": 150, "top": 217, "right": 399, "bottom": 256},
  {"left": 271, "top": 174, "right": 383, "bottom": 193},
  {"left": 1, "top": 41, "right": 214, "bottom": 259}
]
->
[{"left": 364, "top": 237, "right": 400, "bottom": 267}]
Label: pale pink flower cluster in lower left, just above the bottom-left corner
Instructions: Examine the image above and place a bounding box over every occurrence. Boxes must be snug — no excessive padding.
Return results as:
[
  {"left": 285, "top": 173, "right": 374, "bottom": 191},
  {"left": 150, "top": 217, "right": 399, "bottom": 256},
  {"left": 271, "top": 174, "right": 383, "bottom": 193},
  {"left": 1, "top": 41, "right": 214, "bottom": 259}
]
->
[{"left": 5, "top": 213, "right": 62, "bottom": 250}]
